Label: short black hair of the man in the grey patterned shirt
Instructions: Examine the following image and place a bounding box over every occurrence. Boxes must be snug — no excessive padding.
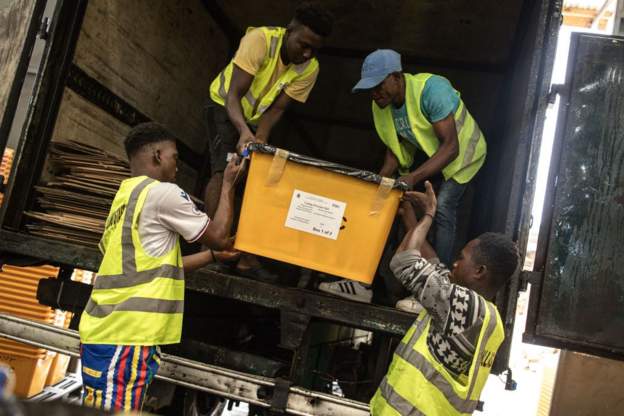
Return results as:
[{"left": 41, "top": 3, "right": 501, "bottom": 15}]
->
[{"left": 472, "top": 233, "right": 520, "bottom": 290}]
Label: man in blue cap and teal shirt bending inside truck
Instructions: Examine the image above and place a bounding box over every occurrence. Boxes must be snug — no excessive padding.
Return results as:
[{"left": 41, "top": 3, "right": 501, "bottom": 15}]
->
[{"left": 320, "top": 49, "right": 487, "bottom": 309}]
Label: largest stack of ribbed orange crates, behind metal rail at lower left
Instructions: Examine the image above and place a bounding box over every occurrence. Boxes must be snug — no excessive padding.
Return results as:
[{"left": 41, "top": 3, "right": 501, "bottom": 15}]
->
[{"left": 0, "top": 265, "right": 58, "bottom": 398}]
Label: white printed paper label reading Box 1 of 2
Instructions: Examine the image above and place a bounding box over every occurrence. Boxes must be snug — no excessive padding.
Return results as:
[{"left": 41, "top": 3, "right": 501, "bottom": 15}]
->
[{"left": 284, "top": 189, "right": 347, "bottom": 240}]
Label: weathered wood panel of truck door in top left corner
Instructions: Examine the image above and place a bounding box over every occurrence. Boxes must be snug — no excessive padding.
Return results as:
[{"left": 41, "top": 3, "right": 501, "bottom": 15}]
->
[{"left": 0, "top": 0, "right": 35, "bottom": 124}]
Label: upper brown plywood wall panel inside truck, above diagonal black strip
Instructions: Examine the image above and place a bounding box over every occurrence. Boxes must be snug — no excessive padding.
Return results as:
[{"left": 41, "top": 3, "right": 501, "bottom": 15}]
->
[{"left": 74, "top": 0, "right": 227, "bottom": 153}]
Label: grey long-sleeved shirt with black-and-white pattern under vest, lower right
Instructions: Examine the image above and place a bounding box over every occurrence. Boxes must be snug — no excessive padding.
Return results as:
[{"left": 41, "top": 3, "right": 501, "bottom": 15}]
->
[{"left": 390, "top": 250, "right": 486, "bottom": 376}]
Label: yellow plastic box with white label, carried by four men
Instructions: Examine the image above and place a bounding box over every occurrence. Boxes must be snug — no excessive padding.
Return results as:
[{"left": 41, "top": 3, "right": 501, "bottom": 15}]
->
[{"left": 234, "top": 145, "right": 402, "bottom": 283}]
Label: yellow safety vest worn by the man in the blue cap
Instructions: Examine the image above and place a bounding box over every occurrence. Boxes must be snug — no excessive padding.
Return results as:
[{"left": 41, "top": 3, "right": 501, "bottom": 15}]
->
[{"left": 373, "top": 74, "right": 487, "bottom": 183}]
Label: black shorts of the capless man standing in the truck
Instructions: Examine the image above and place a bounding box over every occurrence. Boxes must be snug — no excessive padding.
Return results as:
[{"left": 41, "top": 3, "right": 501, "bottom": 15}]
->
[{"left": 204, "top": 99, "right": 239, "bottom": 176}]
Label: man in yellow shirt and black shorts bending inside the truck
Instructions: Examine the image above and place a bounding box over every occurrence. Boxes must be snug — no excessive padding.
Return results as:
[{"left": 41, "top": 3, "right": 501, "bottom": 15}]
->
[{"left": 205, "top": 2, "right": 332, "bottom": 280}]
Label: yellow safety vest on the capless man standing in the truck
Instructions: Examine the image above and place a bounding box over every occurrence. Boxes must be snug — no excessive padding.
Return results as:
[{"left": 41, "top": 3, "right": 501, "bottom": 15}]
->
[{"left": 210, "top": 27, "right": 319, "bottom": 125}]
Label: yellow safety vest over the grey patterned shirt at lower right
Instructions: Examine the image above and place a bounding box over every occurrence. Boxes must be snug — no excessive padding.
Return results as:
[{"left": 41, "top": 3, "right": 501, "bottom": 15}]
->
[{"left": 370, "top": 299, "right": 505, "bottom": 416}]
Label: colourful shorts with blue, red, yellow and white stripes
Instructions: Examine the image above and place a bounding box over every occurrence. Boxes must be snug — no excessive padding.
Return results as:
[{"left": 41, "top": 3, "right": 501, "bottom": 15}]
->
[{"left": 80, "top": 344, "right": 160, "bottom": 411}]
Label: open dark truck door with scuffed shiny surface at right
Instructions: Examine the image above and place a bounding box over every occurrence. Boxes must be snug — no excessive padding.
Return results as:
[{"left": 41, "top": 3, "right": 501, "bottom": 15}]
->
[{"left": 524, "top": 33, "right": 624, "bottom": 359}]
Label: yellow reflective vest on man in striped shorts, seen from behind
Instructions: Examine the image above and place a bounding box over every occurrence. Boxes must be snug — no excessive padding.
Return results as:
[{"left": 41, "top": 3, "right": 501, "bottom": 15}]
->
[{"left": 79, "top": 176, "right": 184, "bottom": 346}]
